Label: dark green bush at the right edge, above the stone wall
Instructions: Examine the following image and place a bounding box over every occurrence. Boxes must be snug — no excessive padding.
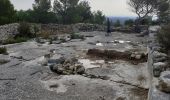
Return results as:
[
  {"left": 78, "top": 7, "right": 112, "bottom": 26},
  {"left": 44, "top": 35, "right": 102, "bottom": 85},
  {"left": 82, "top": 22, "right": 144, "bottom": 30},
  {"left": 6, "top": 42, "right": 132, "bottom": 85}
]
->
[{"left": 157, "top": 24, "right": 170, "bottom": 49}]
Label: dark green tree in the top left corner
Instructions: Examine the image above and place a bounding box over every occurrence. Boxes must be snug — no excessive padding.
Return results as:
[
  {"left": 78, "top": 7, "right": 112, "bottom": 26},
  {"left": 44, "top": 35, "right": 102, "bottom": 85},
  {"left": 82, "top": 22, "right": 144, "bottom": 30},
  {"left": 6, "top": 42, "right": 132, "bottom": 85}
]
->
[{"left": 0, "top": 0, "right": 15, "bottom": 25}]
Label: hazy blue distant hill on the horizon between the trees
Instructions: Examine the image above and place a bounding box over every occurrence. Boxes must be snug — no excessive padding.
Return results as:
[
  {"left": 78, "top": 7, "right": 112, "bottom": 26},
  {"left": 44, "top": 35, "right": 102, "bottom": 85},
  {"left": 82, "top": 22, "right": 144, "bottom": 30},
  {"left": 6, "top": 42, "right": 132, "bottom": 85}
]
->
[{"left": 108, "top": 16, "right": 136, "bottom": 25}]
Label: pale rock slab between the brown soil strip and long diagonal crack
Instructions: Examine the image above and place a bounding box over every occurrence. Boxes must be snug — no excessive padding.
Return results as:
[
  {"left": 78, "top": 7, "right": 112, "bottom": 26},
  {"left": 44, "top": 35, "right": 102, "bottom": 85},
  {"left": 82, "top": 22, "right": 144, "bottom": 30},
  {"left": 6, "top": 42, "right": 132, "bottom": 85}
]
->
[{"left": 86, "top": 61, "right": 149, "bottom": 89}]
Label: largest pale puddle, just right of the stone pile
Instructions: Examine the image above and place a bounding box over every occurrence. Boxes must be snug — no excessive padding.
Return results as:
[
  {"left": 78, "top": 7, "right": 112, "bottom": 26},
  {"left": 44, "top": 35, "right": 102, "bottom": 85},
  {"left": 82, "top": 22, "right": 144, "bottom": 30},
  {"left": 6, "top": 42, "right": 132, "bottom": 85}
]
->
[{"left": 79, "top": 59, "right": 104, "bottom": 69}]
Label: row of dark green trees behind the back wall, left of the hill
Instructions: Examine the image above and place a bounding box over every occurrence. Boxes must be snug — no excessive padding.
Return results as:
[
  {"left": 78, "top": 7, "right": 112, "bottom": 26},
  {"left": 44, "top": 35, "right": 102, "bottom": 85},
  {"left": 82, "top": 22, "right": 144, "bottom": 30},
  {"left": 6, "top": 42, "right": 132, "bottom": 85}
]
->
[{"left": 0, "top": 0, "right": 106, "bottom": 25}]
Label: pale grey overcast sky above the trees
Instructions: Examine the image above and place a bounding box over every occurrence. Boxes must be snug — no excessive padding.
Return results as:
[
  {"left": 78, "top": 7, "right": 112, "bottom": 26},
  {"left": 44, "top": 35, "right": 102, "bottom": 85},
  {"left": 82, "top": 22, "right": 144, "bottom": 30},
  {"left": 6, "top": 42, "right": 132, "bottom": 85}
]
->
[{"left": 11, "top": 0, "right": 135, "bottom": 16}]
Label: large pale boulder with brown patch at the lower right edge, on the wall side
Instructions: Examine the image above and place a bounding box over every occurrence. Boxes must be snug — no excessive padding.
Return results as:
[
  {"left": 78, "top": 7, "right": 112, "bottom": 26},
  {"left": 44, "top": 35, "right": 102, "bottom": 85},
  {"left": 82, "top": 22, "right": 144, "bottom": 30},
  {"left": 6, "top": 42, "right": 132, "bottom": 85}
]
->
[{"left": 158, "top": 71, "right": 170, "bottom": 93}]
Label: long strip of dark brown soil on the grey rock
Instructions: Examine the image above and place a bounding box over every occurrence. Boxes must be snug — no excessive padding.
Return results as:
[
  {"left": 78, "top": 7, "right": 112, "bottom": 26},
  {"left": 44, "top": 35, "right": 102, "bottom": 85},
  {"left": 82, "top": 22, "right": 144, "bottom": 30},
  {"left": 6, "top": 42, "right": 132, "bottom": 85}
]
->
[{"left": 87, "top": 49, "right": 147, "bottom": 64}]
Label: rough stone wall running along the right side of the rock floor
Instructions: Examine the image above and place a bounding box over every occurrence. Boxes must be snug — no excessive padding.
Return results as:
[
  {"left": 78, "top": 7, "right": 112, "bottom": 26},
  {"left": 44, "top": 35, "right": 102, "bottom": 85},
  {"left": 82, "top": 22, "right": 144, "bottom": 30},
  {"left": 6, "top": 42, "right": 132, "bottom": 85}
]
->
[{"left": 148, "top": 27, "right": 170, "bottom": 100}]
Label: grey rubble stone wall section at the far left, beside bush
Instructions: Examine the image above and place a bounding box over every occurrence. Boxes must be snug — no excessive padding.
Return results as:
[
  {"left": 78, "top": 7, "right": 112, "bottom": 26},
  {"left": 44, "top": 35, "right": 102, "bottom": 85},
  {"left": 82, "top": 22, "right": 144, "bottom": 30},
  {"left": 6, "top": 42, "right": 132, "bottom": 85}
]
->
[{"left": 0, "top": 23, "right": 19, "bottom": 40}]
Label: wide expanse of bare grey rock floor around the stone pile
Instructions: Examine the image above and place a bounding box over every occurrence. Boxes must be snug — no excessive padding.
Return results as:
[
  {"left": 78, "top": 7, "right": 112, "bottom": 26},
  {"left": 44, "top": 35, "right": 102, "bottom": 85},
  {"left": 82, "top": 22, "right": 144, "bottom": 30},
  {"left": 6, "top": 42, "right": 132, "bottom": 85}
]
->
[{"left": 0, "top": 32, "right": 149, "bottom": 100}]
